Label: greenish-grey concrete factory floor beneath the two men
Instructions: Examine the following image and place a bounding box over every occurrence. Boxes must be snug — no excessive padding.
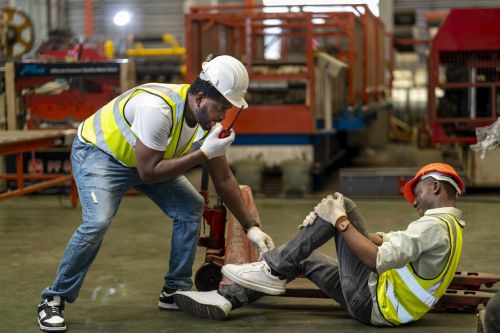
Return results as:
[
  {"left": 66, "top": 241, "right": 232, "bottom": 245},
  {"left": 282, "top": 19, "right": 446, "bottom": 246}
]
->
[{"left": 0, "top": 188, "right": 500, "bottom": 333}]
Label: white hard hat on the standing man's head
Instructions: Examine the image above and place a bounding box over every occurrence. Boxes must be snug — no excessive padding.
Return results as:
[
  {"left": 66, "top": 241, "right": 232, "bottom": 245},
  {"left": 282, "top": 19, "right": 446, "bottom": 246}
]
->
[{"left": 200, "top": 55, "right": 249, "bottom": 109}]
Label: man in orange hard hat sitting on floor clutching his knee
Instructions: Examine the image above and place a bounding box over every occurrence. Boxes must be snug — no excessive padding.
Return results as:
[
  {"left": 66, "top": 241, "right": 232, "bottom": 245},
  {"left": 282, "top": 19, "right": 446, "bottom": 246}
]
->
[{"left": 174, "top": 163, "right": 465, "bottom": 326}]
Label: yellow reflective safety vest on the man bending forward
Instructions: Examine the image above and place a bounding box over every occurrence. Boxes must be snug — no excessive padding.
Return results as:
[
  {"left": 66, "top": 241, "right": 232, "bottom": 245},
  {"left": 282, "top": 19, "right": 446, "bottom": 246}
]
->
[{"left": 81, "top": 83, "right": 208, "bottom": 168}]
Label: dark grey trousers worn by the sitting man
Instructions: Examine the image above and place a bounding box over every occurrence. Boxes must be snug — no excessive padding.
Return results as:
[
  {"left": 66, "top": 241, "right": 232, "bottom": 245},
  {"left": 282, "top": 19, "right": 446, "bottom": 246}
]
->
[{"left": 219, "top": 198, "right": 372, "bottom": 324}]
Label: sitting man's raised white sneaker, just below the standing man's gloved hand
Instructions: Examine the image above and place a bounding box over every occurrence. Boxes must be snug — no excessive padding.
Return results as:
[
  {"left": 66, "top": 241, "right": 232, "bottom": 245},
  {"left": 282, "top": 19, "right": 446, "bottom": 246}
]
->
[{"left": 222, "top": 261, "right": 286, "bottom": 295}]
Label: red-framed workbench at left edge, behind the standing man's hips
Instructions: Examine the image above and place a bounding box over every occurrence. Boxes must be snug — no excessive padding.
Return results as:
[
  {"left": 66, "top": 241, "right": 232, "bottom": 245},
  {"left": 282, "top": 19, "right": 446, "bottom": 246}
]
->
[{"left": 0, "top": 129, "right": 78, "bottom": 207}]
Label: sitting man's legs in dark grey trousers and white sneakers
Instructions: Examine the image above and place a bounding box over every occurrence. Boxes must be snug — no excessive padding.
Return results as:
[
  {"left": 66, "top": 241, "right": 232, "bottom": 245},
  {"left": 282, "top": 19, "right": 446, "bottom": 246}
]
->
[{"left": 176, "top": 198, "right": 371, "bottom": 322}]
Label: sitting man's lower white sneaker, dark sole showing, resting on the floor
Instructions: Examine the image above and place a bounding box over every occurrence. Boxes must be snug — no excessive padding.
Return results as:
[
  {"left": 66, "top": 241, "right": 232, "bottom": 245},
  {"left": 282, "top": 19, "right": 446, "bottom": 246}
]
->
[{"left": 174, "top": 290, "right": 233, "bottom": 320}]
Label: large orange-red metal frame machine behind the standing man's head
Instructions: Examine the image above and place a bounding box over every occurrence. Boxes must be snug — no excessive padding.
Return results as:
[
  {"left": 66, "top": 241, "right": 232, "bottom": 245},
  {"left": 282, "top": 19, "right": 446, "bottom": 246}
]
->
[{"left": 185, "top": 4, "right": 390, "bottom": 134}]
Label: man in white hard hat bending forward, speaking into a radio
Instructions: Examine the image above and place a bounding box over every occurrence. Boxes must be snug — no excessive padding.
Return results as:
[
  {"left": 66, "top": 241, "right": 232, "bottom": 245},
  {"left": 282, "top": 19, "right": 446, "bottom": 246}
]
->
[{"left": 37, "top": 55, "right": 274, "bottom": 332}]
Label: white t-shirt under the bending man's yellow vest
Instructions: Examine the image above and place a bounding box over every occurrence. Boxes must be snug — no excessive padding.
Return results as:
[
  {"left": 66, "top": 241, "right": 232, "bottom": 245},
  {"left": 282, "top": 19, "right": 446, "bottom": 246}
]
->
[{"left": 78, "top": 93, "right": 200, "bottom": 152}]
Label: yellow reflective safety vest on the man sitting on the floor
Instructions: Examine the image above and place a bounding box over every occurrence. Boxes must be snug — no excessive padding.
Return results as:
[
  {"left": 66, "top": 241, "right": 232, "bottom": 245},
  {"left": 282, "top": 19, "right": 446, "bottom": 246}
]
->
[{"left": 377, "top": 214, "right": 462, "bottom": 325}]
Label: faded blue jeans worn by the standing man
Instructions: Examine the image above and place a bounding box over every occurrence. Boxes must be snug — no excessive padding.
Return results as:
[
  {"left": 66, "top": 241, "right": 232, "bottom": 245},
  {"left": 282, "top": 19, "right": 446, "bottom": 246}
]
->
[{"left": 42, "top": 137, "right": 204, "bottom": 303}]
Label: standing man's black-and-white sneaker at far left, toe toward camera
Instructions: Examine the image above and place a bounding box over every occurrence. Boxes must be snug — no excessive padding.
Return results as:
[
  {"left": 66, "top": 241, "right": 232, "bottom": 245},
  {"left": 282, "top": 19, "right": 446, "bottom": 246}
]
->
[{"left": 37, "top": 296, "right": 66, "bottom": 332}]
